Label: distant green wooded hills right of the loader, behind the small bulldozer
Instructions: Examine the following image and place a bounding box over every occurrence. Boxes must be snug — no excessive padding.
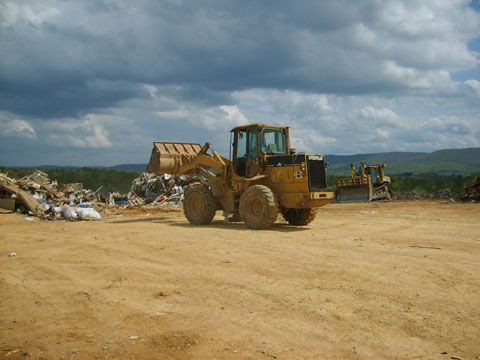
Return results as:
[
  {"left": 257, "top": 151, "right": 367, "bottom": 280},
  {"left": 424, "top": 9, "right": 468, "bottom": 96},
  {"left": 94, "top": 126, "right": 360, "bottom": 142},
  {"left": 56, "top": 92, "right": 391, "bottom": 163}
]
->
[{"left": 326, "top": 148, "right": 480, "bottom": 175}]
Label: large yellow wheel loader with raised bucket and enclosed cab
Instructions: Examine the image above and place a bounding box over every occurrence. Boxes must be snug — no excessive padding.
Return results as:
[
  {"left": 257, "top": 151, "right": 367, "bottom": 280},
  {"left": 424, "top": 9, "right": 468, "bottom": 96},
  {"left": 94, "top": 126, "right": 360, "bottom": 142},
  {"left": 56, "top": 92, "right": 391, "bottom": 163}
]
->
[{"left": 147, "top": 124, "right": 334, "bottom": 229}]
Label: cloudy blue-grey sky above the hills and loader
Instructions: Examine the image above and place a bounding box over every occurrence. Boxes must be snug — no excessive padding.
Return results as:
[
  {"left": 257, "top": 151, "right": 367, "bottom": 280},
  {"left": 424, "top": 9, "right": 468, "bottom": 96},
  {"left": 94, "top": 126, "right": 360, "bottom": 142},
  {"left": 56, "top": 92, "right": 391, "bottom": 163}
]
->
[{"left": 0, "top": 0, "right": 480, "bottom": 166}]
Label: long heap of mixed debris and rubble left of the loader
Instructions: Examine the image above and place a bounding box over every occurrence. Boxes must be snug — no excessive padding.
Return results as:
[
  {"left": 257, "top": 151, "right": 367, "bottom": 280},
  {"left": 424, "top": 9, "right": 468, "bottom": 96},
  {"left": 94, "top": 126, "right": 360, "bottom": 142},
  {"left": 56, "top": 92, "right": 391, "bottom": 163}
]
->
[{"left": 0, "top": 170, "right": 199, "bottom": 219}]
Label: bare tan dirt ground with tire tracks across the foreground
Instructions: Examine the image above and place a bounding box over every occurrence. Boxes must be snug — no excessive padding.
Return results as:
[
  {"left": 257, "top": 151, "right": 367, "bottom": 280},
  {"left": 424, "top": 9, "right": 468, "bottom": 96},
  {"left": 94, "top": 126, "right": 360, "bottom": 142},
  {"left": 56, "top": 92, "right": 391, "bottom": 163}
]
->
[{"left": 0, "top": 201, "right": 480, "bottom": 360}]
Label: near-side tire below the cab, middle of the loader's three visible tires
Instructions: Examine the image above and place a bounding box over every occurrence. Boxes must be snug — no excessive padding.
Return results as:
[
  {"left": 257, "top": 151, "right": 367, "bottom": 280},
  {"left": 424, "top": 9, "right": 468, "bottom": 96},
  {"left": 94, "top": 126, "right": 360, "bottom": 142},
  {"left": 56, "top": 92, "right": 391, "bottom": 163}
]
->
[{"left": 240, "top": 185, "right": 278, "bottom": 229}]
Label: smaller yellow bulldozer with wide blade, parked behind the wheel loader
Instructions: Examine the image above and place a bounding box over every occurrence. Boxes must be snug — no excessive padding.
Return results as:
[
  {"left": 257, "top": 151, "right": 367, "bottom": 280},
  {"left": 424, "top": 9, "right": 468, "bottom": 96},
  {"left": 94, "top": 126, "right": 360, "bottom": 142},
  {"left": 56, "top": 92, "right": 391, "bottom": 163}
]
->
[{"left": 335, "top": 162, "right": 393, "bottom": 203}]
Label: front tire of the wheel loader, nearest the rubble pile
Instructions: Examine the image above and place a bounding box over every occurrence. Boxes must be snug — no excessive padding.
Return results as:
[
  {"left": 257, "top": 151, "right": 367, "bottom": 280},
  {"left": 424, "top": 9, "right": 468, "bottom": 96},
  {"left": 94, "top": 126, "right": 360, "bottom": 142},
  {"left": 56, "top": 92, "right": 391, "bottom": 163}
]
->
[{"left": 183, "top": 185, "right": 218, "bottom": 225}]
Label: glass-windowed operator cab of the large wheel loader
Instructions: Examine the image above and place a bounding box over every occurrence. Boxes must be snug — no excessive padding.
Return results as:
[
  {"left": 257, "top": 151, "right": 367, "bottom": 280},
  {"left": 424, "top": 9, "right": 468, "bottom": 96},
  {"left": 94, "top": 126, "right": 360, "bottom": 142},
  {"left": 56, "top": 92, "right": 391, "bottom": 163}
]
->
[{"left": 232, "top": 124, "right": 290, "bottom": 178}]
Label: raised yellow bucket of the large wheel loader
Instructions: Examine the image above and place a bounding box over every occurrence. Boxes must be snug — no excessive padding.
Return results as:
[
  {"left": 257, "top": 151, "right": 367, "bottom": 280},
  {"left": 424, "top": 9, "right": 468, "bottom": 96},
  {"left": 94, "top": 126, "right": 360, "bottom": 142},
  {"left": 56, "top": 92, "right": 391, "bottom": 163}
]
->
[{"left": 147, "top": 142, "right": 202, "bottom": 175}]
